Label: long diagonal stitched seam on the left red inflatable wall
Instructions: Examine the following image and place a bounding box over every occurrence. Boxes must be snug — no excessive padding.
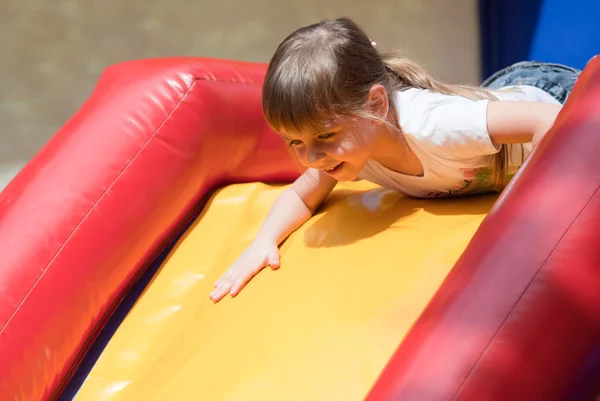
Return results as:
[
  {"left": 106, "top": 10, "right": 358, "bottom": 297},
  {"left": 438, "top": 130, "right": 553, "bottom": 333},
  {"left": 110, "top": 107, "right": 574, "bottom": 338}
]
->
[{"left": 0, "top": 79, "right": 206, "bottom": 335}]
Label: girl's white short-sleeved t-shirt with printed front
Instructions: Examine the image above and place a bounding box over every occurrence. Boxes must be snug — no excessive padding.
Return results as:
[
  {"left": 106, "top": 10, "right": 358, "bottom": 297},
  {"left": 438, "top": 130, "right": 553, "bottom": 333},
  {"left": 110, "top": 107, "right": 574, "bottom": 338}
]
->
[{"left": 358, "top": 85, "right": 560, "bottom": 198}]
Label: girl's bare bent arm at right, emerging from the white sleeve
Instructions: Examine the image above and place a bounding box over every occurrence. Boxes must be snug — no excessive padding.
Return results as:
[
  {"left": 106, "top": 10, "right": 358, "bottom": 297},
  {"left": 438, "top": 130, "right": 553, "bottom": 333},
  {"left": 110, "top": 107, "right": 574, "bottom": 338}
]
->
[{"left": 487, "top": 101, "right": 562, "bottom": 146}]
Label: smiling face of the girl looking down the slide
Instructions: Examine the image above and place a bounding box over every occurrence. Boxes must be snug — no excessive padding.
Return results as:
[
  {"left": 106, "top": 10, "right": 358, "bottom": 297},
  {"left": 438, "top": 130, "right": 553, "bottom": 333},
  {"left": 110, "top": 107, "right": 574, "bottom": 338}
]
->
[{"left": 282, "top": 117, "right": 376, "bottom": 181}]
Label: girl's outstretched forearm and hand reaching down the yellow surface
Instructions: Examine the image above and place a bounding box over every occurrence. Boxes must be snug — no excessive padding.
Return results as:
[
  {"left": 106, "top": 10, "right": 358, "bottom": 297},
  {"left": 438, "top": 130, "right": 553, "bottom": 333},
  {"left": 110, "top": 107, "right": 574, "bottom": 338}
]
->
[{"left": 210, "top": 169, "right": 337, "bottom": 302}]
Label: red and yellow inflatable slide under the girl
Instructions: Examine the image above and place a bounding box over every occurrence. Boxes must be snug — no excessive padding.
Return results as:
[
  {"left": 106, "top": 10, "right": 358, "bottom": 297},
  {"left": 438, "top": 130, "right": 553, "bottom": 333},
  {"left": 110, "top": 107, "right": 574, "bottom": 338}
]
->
[{"left": 0, "top": 54, "right": 600, "bottom": 401}]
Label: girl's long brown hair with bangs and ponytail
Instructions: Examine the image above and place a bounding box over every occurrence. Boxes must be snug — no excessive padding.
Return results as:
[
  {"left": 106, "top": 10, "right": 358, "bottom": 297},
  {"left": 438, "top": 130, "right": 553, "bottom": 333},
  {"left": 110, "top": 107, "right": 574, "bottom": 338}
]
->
[{"left": 262, "top": 18, "right": 508, "bottom": 191}]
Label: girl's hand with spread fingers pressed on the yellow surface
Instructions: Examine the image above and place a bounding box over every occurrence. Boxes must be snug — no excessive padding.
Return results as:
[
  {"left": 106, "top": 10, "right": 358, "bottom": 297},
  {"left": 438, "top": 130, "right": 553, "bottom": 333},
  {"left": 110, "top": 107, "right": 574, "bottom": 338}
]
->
[{"left": 210, "top": 240, "right": 279, "bottom": 302}]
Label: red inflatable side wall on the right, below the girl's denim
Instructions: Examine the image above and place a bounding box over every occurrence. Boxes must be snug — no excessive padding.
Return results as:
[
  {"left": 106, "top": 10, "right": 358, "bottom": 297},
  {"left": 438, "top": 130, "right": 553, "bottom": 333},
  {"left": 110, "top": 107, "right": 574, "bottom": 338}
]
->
[{"left": 368, "top": 58, "right": 600, "bottom": 401}]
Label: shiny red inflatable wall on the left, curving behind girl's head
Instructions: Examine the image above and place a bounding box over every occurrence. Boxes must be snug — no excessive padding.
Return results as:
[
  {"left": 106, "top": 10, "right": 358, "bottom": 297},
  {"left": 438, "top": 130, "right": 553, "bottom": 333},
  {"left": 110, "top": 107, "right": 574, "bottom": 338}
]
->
[{"left": 0, "top": 58, "right": 299, "bottom": 401}]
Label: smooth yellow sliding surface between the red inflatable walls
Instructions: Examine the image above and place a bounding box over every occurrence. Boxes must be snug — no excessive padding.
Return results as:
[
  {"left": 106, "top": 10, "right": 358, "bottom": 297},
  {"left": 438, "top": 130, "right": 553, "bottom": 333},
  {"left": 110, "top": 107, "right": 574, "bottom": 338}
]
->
[{"left": 75, "top": 182, "right": 496, "bottom": 401}]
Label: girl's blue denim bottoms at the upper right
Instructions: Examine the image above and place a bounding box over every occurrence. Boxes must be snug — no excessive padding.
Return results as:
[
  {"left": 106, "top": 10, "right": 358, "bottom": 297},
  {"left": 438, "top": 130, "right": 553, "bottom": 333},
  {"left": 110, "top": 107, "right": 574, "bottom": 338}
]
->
[{"left": 481, "top": 61, "right": 581, "bottom": 104}]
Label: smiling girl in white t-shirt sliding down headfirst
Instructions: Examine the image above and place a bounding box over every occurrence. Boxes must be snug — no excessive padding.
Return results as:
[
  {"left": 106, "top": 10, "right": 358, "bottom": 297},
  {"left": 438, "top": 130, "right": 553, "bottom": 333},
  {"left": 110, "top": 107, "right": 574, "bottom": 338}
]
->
[{"left": 210, "top": 18, "right": 579, "bottom": 302}]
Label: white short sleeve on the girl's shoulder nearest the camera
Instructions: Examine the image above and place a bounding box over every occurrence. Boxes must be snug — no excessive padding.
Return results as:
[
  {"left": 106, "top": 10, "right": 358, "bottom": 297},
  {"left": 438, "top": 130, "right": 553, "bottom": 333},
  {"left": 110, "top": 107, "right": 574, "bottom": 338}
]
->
[{"left": 399, "top": 90, "right": 500, "bottom": 159}]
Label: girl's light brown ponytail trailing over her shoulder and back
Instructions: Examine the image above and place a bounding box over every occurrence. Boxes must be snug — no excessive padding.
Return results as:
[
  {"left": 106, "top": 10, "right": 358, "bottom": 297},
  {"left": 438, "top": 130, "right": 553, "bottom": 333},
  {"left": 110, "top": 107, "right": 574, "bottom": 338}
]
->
[{"left": 382, "top": 54, "right": 508, "bottom": 192}]
